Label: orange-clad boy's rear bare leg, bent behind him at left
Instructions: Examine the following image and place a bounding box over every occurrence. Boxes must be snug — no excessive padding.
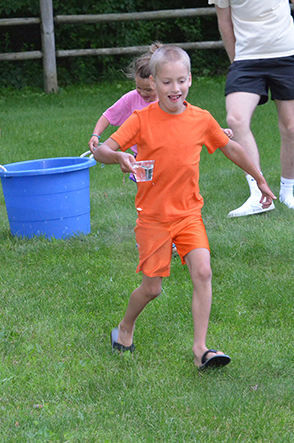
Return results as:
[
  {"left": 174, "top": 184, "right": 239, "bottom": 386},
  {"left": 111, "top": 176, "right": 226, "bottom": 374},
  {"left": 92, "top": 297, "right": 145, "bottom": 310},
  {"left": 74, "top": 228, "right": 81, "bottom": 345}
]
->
[{"left": 117, "top": 274, "right": 162, "bottom": 347}]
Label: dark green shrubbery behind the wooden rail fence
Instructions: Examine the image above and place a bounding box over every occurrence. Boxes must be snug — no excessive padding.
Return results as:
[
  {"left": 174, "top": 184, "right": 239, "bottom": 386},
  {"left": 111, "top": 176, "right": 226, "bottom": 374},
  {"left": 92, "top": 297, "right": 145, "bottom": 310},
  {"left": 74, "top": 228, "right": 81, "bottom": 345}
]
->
[{"left": 0, "top": 0, "right": 228, "bottom": 88}]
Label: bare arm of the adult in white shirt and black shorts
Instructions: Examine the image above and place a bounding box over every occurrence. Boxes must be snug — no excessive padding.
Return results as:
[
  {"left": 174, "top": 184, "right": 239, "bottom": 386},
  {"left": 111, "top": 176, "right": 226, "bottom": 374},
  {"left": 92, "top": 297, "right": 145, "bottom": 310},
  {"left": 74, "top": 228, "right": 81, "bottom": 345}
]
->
[{"left": 215, "top": 5, "right": 237, "bottom": 63}]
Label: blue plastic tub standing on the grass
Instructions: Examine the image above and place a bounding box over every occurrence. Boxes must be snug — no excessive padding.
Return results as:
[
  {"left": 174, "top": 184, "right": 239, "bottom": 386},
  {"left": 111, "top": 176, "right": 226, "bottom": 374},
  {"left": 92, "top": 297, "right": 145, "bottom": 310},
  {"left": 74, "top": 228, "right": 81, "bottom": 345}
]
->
[{"left": 0, "top": 157, "right": 96, "bottom": 239}]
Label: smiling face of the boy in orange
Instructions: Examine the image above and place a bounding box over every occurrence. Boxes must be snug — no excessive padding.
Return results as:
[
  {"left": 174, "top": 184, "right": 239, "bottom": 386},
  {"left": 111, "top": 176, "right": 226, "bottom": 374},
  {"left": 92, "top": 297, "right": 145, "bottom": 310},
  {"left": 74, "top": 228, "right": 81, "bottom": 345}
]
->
[{"left": 150, "top": 61, "right": 192, "bottom": 114}]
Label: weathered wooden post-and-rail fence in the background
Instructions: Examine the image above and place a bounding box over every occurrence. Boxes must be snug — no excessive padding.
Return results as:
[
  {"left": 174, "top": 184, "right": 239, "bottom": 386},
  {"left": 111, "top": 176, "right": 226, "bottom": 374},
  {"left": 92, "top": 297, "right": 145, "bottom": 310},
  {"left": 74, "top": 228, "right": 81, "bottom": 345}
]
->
[{"left": 0, "top": 0, "right": 223, "bottom": 93}]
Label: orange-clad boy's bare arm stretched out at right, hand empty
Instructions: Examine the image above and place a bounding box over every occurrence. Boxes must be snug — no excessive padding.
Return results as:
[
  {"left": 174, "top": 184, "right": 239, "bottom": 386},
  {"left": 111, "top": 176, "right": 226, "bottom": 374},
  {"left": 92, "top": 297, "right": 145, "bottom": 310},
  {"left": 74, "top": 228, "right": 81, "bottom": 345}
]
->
[{"left": 220, "top": 140, "right": 276, "bottom": 208}]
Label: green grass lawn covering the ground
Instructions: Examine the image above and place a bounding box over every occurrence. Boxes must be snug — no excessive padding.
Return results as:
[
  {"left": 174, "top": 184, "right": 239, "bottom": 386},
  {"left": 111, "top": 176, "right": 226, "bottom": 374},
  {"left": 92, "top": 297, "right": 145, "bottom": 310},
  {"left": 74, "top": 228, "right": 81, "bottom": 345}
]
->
[{"left": 0, "top": 78, "right": 294, "bottom": 443}]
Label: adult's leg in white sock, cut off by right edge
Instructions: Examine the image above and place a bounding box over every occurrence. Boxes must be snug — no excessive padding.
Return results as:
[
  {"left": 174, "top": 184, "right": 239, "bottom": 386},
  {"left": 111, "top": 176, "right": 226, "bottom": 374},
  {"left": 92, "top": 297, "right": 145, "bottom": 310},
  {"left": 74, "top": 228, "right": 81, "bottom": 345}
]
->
[{"left": 275, "top": 100, "right": 294, "bottom": 209}]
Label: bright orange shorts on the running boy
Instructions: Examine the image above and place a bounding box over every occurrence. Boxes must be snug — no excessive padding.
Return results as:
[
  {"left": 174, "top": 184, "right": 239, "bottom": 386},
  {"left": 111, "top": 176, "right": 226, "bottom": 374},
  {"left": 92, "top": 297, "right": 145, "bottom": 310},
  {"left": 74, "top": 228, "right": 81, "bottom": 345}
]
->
[{"left": 135, "top": 214, "right": 210, "bottom": 277}]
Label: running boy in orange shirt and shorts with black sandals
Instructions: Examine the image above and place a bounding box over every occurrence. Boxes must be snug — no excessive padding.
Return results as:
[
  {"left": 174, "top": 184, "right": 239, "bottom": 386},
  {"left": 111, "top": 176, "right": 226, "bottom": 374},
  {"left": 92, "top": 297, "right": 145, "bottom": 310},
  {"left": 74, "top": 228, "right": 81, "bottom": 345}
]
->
[{"left": 94, "top": 45, "right": 275, "bottom": 369}]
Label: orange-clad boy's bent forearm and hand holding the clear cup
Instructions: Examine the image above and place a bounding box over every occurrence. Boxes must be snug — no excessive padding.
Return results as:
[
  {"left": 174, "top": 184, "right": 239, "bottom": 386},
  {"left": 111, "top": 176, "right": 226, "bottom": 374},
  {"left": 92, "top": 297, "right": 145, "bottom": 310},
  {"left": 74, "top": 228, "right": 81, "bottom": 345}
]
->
[{"left": 94, "top": 138, "right": 136, "bottom": 173}]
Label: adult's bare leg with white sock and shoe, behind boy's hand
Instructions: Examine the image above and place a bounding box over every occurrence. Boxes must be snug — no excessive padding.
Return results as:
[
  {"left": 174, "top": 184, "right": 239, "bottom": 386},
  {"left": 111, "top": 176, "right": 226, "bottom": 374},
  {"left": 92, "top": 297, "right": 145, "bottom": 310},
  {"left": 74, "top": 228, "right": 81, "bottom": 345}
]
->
[{"left": 226, "top": 92, "right": 274, "bottom": 217}]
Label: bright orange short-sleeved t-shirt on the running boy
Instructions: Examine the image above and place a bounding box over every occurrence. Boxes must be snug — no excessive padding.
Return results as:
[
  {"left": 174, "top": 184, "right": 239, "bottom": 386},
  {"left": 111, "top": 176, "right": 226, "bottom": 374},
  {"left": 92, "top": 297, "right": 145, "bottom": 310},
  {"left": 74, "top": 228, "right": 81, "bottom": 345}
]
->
[{"left": 111, "top": 102, "right": 229, "bottom": 222}]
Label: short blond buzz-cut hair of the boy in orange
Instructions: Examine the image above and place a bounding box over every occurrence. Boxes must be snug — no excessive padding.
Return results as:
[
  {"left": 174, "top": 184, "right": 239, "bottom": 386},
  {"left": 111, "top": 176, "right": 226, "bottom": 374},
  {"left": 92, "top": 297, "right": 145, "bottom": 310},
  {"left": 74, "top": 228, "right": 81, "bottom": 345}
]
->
[{"left": 150, "top": 45, "right": 191, "bottom": 78}]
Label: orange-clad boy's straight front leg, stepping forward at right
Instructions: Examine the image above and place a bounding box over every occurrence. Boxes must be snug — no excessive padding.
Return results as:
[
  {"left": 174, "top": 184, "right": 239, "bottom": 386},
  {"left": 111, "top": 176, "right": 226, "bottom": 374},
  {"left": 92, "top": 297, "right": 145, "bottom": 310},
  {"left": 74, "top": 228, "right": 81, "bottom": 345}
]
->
[{"left": 185, "top": 248, "right": 223, "bottom": 367}]
